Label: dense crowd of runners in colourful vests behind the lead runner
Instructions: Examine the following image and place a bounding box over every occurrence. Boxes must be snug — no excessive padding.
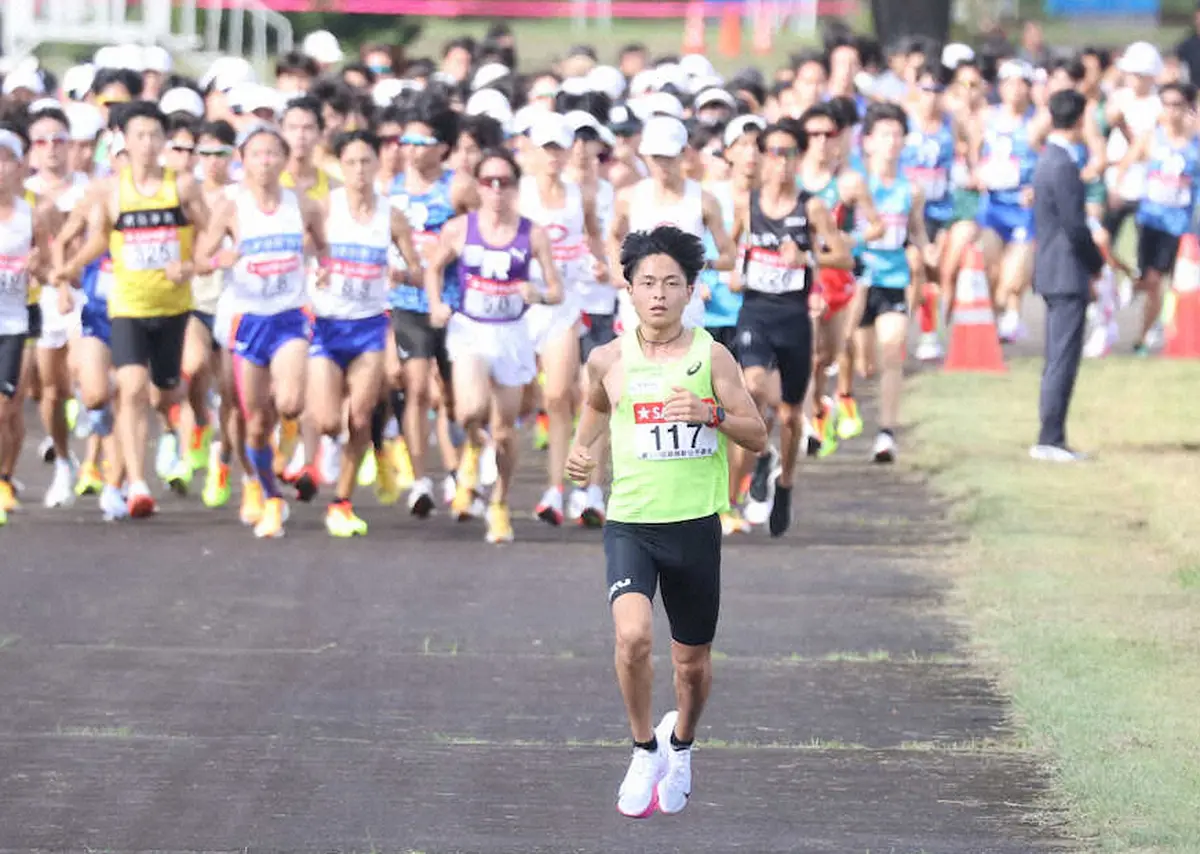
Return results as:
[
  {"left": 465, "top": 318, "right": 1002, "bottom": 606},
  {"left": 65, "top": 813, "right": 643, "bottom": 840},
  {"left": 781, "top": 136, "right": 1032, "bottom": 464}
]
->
[{"left": 0, "top": 26, "right": 1185, "bottom": 542}]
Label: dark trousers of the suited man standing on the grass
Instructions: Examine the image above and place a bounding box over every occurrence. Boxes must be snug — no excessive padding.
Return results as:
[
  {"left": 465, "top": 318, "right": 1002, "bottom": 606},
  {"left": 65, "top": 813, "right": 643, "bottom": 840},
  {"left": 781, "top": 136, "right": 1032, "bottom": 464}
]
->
[{"left": 1038, "top": 296, "right": 1087, "bottom": 447}]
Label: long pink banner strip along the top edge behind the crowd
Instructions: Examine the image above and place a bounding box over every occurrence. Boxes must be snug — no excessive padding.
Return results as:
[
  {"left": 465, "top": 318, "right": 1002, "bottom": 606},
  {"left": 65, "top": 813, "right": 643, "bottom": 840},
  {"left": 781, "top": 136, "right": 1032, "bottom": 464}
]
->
[{"left": 234, "top": 0, "right": 858, "bottom": 18}]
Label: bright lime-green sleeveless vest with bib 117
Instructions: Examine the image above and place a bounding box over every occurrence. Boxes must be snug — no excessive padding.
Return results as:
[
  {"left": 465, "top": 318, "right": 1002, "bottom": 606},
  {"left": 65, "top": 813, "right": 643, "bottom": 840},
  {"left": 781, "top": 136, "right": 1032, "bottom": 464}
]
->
[{"left": 608, "top": 329, "right": 730, "bottom": 523}]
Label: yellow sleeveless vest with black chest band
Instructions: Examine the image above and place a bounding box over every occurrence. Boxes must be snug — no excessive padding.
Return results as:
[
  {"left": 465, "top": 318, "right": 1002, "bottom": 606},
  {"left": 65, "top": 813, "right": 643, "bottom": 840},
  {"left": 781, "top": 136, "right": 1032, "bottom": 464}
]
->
[{"left": 108, "top": 167, "right": 193, "bottom": 318}]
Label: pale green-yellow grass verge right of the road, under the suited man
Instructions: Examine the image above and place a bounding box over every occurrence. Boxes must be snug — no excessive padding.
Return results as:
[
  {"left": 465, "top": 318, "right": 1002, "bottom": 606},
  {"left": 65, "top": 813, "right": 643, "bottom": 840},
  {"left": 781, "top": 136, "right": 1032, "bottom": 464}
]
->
[{"left": 906, "top": 359, "right": 1200, "bottom": 854}]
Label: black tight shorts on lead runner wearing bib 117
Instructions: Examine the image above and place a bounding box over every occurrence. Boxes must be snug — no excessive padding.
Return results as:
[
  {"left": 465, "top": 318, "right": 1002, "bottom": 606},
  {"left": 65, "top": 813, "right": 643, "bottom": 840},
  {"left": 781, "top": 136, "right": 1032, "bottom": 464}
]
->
[{"left": 604, "top": 513, "right": 721, "bottom": 646}]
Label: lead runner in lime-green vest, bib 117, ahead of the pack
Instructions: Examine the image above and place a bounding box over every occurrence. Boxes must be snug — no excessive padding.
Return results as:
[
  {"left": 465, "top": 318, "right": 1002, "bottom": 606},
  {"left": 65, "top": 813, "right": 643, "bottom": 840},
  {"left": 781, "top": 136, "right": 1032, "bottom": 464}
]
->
[{"left": 566, "top": 225, "right": 767, "bottom": 818}]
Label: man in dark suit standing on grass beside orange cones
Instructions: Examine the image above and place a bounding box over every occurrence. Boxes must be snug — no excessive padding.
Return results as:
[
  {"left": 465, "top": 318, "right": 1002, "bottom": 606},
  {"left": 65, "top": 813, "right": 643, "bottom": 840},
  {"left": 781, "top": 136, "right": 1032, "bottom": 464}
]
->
[{"left": 1030, "top": 90, "right": 1104, "bottom": 462}]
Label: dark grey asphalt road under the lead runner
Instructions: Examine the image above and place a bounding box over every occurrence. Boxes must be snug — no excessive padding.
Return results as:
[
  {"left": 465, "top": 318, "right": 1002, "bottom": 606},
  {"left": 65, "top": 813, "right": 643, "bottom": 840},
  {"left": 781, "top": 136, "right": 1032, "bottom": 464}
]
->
[{"left": 0, "top": 386, "right": 1064, "bottom": 854}]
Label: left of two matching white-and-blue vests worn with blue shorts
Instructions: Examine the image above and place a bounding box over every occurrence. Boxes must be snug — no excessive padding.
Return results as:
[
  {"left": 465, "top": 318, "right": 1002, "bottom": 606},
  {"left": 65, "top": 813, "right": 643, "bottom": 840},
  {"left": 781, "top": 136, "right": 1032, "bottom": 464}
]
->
[{"left": 227, "top": 190, "right": 307, "bottom": 314}]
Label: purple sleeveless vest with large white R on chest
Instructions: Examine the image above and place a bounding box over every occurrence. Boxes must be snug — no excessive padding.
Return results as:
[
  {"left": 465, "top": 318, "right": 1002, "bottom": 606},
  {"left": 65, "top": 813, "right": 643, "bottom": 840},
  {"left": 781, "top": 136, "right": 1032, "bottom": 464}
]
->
[{"left": 458, "top": 212, "right": 533, "bottom": 323}]
